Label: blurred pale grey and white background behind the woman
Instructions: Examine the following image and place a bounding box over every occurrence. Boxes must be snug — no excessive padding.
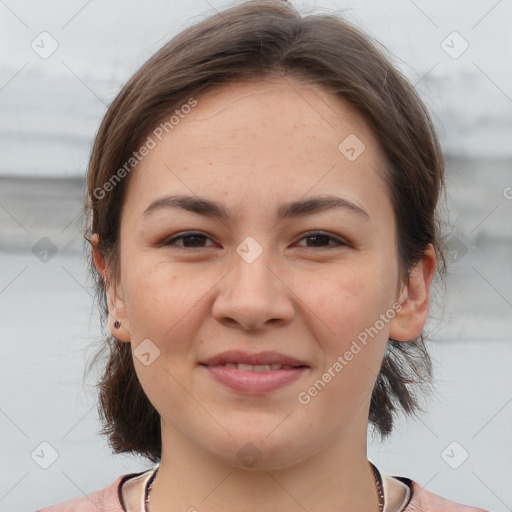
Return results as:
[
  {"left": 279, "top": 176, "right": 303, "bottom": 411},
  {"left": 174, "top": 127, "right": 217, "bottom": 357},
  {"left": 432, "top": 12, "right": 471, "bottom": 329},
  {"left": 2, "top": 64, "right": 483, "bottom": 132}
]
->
[{"left": 0, "top": 0, "right": 512, "bottom": 512}]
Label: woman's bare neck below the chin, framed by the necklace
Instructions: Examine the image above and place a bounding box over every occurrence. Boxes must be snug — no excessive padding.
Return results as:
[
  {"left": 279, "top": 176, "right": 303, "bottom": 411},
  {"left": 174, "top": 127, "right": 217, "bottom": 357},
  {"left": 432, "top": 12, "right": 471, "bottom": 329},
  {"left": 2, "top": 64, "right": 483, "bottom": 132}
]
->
[{"left": 149, "top": 418, "right": 379, "bottom": 512}]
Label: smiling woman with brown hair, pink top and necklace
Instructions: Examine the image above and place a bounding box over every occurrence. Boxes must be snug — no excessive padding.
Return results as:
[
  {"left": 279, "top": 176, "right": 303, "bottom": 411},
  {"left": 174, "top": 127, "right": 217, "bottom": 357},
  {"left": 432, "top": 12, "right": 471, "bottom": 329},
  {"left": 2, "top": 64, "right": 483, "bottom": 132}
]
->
[{"left": 37, "top": 1, "right": 488, "bottom": 512}]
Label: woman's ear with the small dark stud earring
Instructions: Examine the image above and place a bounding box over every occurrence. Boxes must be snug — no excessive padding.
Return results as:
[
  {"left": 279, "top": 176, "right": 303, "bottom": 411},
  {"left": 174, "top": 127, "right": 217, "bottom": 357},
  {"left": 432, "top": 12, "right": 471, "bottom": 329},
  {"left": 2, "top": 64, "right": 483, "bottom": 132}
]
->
[{"left": 91, "top": 233, "right": 131, "bottom": 342}]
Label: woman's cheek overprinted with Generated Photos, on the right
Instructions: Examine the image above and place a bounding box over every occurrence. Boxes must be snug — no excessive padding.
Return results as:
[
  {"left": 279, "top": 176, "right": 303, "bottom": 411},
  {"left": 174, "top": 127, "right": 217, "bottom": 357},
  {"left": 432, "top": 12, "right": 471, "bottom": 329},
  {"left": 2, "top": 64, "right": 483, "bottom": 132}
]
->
[{"left": 306, "top": 261, "right": 394, "bottom": 400}]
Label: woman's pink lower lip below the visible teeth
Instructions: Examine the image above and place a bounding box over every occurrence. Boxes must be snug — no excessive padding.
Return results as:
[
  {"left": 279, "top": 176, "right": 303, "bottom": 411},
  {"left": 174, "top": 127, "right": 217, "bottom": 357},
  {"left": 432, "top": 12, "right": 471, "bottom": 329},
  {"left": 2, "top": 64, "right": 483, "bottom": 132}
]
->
[{"left": 202, "top": 365, "right": 308, "bottom": 395}]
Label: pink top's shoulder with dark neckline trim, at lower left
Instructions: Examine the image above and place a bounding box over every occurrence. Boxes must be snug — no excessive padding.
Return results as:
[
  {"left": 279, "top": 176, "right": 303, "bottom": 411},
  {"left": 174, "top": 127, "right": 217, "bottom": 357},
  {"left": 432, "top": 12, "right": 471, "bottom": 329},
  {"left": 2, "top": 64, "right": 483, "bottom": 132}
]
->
[{"left": 36, "top": 473, "right": 139, "bottom": 512}]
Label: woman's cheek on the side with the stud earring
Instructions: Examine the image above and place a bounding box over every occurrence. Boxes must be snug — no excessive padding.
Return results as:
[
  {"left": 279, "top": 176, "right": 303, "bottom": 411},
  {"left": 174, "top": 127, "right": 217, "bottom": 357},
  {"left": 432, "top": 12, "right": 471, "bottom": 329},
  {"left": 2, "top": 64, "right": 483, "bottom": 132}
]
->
[{"left": 125, "top": 258, "right": 206, "bottom": 418}]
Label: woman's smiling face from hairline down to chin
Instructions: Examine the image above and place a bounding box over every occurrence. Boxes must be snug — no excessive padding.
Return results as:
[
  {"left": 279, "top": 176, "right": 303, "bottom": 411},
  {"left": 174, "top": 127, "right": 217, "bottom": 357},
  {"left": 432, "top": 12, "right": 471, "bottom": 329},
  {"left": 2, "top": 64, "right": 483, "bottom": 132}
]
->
[{"left": 99, "top": 75, "right": 428, "bottom": 468}]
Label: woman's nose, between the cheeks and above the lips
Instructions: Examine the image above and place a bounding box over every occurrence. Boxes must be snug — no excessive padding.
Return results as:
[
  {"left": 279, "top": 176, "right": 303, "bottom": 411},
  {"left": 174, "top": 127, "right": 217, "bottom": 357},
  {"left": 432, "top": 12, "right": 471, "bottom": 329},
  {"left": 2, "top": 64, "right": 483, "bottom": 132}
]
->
[{"left": 212, "top": 251, "right": 295, "bottom": 330}]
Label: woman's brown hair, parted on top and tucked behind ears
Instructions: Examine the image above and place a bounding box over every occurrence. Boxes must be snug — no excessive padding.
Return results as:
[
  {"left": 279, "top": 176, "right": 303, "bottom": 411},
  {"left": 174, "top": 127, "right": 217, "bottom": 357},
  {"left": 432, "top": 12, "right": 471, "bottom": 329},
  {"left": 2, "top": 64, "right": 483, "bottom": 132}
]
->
[{"left": 85, "top": 0, "right": 446, "bottom": 462}]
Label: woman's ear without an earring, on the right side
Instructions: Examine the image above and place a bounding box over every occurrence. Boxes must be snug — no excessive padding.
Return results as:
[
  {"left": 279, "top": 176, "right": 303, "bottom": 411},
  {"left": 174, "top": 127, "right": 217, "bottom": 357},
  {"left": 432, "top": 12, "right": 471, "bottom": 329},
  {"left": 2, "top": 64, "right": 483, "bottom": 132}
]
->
[{"left": 389, "top": 244, "right": 436, "bottom": 341}]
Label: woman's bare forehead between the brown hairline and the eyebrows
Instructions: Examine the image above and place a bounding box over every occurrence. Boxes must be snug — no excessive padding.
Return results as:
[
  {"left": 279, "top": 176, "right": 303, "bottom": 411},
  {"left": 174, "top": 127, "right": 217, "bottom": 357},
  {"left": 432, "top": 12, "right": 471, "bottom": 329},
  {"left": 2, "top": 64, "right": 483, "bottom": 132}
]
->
[{"left": 123, "top": 77, "right": 387, "bottom": 224}]
